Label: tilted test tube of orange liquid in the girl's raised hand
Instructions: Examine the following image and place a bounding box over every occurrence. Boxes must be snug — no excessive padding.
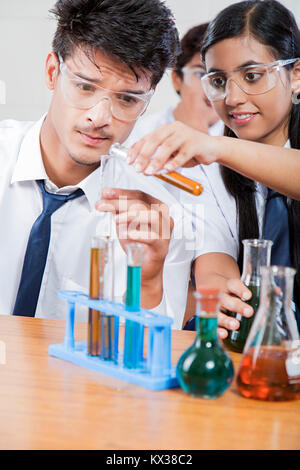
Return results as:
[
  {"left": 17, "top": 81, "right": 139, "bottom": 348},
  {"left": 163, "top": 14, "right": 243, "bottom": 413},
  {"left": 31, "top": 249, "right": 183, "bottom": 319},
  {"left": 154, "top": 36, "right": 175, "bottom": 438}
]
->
[{"left": 109, "top": 143, "right": 203, "bottom": 196}]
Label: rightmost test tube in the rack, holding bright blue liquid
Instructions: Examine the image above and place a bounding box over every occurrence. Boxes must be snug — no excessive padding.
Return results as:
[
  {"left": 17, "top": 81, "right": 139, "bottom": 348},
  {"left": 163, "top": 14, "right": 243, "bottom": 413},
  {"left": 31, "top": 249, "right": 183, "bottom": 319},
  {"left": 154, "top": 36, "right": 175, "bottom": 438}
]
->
[{"left": 123, "top": 243, "right": 144, "bottom": 369}]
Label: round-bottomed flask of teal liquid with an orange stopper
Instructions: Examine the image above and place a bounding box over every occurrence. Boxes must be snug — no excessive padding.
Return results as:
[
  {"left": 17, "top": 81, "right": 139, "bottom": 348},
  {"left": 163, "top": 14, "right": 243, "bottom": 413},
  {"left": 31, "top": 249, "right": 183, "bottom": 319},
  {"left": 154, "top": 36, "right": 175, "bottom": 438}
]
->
[{"left": 176, "top": 288, "right": 234, "bottom": 398}]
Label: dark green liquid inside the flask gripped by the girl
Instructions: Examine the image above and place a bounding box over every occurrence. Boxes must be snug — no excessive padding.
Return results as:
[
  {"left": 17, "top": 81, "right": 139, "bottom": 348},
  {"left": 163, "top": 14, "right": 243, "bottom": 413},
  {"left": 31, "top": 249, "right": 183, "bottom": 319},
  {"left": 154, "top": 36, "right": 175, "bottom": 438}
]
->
[{"left": 223, "top": 286, "right": 260, "bottom": 353}]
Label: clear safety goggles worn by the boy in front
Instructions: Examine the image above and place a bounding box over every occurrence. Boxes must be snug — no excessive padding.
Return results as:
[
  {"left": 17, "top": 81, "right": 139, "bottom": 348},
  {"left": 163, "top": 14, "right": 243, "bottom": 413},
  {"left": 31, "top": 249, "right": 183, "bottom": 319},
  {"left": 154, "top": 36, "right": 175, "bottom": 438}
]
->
[{"left": 59, "top": 58, "right": 154, "bottom": 121}]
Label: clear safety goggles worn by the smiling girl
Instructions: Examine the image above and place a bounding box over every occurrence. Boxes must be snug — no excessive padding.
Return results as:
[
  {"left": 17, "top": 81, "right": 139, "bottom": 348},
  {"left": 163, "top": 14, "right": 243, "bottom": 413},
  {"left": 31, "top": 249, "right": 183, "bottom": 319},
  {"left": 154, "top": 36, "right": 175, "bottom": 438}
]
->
[{"left": 201, "top": 58, "right": 299, "bottom": 101}]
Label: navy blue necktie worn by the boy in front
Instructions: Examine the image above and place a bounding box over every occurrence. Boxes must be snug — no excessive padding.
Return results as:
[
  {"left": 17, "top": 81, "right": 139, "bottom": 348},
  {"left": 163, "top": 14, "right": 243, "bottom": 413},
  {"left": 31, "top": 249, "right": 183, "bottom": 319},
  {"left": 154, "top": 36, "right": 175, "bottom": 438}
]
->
[{"left": 13, "top": 180, "right": 84, "bottom": 317}]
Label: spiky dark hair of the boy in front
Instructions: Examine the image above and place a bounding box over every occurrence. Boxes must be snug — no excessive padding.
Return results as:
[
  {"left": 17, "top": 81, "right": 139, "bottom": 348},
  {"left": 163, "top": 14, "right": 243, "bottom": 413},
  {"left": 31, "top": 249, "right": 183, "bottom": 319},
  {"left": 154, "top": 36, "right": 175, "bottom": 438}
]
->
[{"left": 50, "top": 0, "right": 179, "bottom": 85}]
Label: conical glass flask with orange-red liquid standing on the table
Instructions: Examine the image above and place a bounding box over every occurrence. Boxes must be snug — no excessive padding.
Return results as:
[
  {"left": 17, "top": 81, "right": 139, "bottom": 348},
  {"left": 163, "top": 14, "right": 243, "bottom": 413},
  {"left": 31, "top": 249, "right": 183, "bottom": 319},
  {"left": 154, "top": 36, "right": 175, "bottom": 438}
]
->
[{"left": 237, "top": 266, "right": 300, "bottom": 401}]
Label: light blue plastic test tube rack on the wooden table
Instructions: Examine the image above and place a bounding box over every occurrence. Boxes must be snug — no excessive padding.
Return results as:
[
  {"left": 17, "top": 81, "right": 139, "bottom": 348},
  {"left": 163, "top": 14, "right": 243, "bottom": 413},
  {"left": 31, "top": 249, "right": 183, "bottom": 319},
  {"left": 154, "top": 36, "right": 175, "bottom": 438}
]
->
[{"left": 48, "top": 291, "right": 179, "bottom": 390}]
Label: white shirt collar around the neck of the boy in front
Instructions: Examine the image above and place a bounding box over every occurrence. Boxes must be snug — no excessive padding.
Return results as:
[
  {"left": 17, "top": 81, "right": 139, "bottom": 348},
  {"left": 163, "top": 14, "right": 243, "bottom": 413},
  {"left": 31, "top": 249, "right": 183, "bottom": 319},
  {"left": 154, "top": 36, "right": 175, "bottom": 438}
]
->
[{"left": 11, "top": 114, "right": 100, "bottom": 210}]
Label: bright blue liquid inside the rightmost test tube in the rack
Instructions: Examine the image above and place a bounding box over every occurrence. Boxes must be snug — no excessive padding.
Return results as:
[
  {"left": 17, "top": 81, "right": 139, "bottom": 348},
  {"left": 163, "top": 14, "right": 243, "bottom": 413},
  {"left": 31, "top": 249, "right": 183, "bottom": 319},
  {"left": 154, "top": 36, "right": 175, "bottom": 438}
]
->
[{"left": 124, "top": 266, "right": 144, "bottom": 369}]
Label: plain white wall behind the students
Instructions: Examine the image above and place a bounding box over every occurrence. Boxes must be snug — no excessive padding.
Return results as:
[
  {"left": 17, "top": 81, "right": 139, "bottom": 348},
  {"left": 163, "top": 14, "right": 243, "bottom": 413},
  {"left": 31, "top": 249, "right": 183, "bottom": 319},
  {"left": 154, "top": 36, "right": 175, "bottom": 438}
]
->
[{"left": 0, "top": 0, "right": 300, "bottom": 120}]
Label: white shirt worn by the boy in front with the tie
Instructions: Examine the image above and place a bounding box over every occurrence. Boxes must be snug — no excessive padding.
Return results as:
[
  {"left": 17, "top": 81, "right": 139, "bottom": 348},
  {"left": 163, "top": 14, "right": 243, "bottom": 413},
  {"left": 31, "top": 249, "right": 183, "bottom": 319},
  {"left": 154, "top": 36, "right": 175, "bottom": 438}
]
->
[{"left": 0, "top": 117, "right": 193, "bottom": 328}]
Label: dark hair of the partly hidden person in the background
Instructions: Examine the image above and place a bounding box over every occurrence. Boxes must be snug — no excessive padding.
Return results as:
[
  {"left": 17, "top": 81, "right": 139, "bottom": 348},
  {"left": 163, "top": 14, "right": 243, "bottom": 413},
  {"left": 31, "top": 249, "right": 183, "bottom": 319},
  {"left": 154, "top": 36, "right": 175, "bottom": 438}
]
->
[{"left": 174, "top": 23, "right": 209, "bottom": 78}]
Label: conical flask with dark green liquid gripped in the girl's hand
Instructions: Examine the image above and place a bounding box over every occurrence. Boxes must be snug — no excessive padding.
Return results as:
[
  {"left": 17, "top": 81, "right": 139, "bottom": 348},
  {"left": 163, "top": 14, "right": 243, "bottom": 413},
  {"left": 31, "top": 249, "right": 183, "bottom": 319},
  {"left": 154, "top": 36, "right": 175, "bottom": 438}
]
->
[{"left": 223, "top": 239, "right": 273, "bottom": 353}]
